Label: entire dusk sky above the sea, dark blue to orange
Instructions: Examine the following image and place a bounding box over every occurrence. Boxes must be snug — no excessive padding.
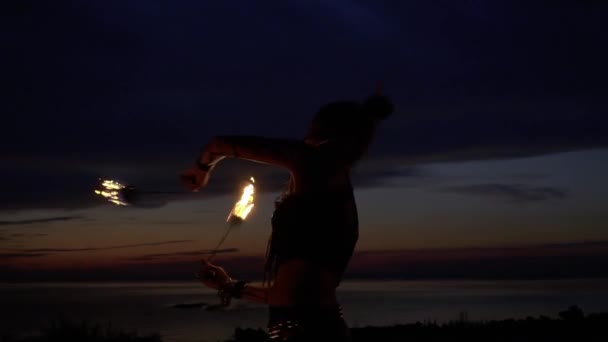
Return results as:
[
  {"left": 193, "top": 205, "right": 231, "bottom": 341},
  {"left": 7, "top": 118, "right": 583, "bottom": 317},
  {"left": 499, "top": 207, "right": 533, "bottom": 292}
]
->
[{"left": 0, "top": 0, "right": 608, "bottom": 281}]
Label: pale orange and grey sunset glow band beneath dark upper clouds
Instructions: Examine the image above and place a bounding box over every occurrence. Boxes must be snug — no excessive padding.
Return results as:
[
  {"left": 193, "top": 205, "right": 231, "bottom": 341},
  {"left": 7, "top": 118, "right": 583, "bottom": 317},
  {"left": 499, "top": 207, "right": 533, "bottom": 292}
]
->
[{"left": 0, "top": 151, "right": 608, "bottom": 280}]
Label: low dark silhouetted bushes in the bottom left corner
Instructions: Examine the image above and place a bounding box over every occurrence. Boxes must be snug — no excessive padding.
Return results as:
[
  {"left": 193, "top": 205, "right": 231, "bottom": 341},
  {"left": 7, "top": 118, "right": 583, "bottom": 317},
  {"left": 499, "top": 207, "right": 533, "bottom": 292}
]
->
[{"left": 0, "top": 319, "right": 162, "bottom": 342}]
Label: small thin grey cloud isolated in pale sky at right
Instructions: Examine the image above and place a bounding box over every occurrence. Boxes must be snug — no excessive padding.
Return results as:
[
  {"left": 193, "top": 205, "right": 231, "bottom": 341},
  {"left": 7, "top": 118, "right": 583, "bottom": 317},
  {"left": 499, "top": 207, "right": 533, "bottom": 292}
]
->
[{"left": 442, "top": 183, "right": 568, "bottom": 203}]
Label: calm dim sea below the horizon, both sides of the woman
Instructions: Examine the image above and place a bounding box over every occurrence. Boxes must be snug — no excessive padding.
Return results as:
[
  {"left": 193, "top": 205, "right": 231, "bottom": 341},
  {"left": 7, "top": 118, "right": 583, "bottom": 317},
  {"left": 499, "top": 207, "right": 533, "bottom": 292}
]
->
[{"left": 0, "top": 279, "right": 608, "bottom": 342}]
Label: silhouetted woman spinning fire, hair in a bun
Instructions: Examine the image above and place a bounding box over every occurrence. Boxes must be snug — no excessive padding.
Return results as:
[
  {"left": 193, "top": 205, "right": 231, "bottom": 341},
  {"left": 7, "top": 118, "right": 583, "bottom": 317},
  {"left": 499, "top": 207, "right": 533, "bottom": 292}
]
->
[{"left": 182, "top": 84, "right": 393, "bottom": 341}]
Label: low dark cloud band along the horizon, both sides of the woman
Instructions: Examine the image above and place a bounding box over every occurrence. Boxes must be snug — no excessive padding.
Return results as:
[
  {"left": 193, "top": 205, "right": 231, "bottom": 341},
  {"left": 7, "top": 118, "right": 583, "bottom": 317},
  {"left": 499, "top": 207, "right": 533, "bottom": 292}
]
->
[{"left": 0, "top": 241, "right": 608, "bottom": 281}]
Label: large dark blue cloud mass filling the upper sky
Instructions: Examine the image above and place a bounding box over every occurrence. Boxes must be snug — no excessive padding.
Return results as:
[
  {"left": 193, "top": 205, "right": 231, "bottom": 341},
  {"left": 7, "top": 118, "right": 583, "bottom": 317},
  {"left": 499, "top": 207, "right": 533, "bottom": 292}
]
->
[{"left": 0, "top": 0, "right": 608, "bottom": 208}]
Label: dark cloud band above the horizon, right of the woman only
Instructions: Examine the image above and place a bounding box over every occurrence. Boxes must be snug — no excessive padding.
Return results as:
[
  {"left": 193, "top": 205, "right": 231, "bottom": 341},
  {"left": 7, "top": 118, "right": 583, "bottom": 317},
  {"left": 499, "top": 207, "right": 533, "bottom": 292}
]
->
[{"left": 346, "top": 241, "right": 608, "bottom": 279}]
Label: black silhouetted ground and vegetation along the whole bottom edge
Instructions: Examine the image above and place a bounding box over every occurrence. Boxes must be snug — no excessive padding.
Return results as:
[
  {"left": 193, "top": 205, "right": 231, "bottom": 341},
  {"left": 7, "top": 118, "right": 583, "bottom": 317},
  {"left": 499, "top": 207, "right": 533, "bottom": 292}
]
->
[{"left": 0, "top": 306, "right": 608, "bottom": 342}]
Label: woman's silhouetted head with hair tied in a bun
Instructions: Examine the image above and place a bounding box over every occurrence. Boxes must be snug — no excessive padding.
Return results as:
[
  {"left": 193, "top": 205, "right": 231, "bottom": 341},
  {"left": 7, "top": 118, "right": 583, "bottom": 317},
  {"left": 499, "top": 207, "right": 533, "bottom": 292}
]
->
[{"left": 305, "top": 95, "right": 393, "bottom": 165}]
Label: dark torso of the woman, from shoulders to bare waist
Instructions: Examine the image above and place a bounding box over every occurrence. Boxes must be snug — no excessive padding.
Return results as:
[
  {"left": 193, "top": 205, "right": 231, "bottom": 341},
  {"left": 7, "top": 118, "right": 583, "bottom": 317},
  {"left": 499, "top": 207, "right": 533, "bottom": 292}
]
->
[{"left": 269, "top": 148, "right": 358, "bottom": 307}]
